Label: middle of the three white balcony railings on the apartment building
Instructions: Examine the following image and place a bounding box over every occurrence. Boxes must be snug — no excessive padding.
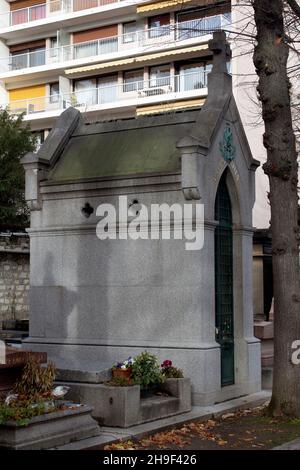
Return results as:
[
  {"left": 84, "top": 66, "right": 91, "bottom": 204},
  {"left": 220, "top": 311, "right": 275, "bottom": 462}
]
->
[{"left": 0, "top": 15, "right": 230, "bottom": 72}]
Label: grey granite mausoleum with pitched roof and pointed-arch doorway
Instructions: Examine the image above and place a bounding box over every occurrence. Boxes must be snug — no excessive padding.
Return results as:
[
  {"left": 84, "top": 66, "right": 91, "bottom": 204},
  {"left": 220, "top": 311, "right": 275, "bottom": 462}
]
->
[{"left": 23, "top": 32, "right": 261, "bottom": 404}]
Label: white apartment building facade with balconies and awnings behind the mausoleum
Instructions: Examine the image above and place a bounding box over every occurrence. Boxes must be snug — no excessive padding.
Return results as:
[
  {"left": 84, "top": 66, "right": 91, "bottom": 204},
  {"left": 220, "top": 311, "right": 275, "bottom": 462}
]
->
[{"left": 0, "top": 0, "right": 231, "bottom": 142}]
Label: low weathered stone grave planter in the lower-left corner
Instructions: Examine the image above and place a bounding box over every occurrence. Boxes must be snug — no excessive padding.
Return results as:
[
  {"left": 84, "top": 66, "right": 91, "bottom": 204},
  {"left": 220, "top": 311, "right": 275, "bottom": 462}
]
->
[{"left": 0, "top": 406, "right": 100, "bottom": 450}]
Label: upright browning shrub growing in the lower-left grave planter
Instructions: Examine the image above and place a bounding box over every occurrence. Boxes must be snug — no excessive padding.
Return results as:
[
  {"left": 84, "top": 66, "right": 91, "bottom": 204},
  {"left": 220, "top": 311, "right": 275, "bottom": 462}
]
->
[{"left": 14, "top": 358, "right": 56, "bottom": 400}]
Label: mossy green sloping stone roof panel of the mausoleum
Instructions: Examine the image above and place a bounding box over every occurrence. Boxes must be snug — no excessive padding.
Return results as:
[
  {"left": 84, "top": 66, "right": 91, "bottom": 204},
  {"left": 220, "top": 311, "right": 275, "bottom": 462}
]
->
[{"left": 48, "top": 111, "right": 199, "bottom": 182}]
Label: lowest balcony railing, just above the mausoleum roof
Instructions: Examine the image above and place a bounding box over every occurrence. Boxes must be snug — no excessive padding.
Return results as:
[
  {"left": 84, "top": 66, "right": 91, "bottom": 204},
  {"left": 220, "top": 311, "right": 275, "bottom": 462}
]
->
[{"left": 7, "top": 70, "right": 207, "bottom": 117}]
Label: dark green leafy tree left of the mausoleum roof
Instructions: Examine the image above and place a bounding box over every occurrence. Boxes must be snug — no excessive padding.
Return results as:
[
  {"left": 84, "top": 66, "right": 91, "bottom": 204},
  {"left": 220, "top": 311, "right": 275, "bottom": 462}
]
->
[{"left": 0, "top": 110, "right": 35, "bottom": 227}]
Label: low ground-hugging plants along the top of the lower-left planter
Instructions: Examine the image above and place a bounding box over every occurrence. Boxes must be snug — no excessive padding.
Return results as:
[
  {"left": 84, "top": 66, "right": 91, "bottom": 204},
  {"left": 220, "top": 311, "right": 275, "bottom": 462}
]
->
[{"left": 0, "top": 400, "right": 56, "bottom": 426}]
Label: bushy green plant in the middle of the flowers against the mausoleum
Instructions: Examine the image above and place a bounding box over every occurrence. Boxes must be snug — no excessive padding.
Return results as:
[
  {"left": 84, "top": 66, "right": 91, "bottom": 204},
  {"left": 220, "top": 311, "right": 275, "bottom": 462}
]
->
[{"left": 132, "top": 351, "right": 165, "bottom": 389}]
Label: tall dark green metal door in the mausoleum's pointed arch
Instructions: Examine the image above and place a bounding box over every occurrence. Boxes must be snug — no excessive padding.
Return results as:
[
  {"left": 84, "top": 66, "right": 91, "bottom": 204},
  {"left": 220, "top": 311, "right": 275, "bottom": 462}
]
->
[{"left": 215, "top": 173, "right": 234, "bottom": 386}]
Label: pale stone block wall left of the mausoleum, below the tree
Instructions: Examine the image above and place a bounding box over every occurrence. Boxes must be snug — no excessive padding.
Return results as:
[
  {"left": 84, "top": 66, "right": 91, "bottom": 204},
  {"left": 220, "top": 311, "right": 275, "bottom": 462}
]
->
[{"left": 0, "top": 232, "right": 29, "bottom": 327}]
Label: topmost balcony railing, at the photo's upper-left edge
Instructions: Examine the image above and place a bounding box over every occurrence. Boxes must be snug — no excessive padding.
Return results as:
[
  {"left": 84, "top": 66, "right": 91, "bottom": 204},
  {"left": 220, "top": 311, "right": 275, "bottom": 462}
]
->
[{"left": 0, "top": 0, "right": 148, "bottom": 28}]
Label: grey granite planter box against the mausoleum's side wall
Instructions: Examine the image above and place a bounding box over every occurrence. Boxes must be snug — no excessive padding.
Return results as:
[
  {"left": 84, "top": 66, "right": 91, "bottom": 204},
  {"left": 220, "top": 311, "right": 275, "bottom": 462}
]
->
[{"left": 62, "top": 378, "right": 191, "bottom": 428}]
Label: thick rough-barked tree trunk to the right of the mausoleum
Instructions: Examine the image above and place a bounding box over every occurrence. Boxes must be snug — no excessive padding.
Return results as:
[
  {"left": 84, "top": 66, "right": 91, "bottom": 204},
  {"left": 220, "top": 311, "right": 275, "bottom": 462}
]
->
[{"left": 253, "top": 0, "right": 300, "bottom": 417}]
